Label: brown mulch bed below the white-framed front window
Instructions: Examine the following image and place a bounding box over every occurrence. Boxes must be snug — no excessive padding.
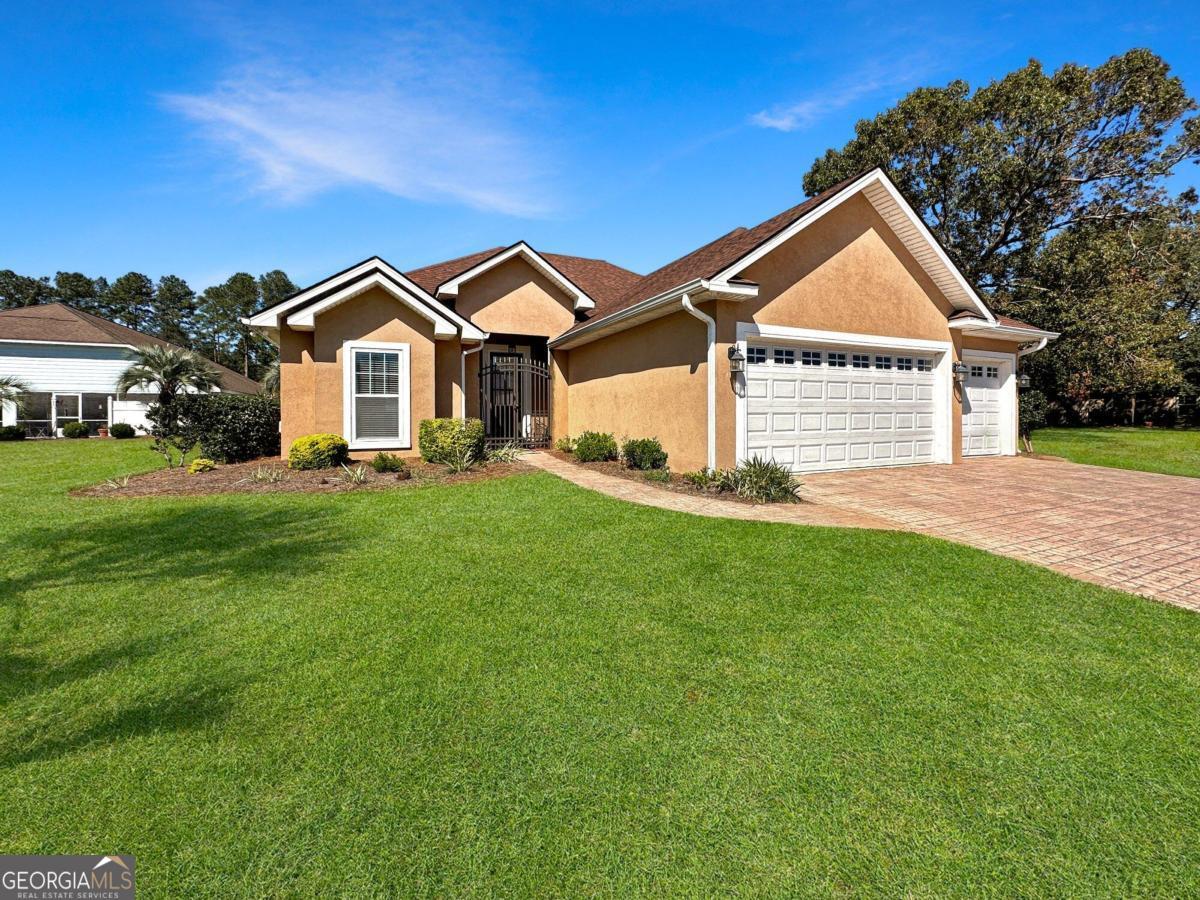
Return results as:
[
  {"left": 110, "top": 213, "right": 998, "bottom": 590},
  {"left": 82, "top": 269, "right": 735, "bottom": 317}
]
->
[{"left": 71, "top": 456, "right": 529, "bottom": 498}]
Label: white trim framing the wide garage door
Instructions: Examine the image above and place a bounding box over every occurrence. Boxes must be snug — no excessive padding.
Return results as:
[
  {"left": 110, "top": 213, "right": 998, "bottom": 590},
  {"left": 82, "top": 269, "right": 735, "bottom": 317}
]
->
[{"left": 734, "top": 322, "right": 954, "bottom": 475}]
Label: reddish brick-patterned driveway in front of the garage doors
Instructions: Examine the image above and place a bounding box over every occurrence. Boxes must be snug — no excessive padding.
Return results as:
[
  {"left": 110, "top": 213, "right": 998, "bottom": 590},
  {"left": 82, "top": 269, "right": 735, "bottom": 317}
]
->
[{"left": 804, "top": 457, "right": 1200, "bottom": 611}]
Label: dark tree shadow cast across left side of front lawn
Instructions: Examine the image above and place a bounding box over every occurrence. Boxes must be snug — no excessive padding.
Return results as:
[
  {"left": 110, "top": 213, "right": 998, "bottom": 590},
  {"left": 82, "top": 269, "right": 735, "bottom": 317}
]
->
[{"left": 0, "top": 502, "right": 346, "bottom": 767}]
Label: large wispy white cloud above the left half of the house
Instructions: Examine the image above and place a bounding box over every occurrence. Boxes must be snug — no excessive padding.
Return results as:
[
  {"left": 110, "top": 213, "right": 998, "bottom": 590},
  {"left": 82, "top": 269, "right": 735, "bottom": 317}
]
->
[{"left": 162, "top": 10, "right": 556, "bottom": 216}]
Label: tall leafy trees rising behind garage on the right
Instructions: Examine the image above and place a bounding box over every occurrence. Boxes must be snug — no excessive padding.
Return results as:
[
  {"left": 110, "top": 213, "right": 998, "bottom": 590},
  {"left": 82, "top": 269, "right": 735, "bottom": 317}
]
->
[{"left": 804, "top": 49, "right": 1200, "bottom": 422}]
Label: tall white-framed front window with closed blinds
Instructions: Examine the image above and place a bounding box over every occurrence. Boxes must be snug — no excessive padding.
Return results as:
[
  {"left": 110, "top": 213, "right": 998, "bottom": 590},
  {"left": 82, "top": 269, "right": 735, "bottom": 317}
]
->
[{"left": 347, "top": 344, "right": 408, "bottom": 446}]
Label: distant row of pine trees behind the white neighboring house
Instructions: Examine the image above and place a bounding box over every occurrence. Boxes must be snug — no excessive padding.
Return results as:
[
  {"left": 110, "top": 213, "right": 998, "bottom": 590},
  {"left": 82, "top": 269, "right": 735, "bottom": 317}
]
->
[{"left": 0, "top": 269, "right": 296, "bottom": 380}]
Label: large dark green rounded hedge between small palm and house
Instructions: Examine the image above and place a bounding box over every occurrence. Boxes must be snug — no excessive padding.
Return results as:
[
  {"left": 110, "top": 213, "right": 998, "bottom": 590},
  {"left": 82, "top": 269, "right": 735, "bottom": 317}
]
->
[{"left": 172, "top": 394, "right": 280, "bottom": 462}]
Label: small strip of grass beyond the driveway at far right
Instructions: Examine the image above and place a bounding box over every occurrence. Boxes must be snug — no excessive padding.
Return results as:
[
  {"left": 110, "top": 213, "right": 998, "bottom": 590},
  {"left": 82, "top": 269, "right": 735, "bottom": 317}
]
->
[{"left": 1033, "top": 428, "right": 1200, "bottom": 478}]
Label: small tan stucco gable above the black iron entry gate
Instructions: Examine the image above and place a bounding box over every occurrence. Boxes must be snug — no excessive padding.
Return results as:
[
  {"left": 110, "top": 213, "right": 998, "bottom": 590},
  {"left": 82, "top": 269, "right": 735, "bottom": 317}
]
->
[{"left": 455, "top": 257, "right": 575, "bottom": 337}]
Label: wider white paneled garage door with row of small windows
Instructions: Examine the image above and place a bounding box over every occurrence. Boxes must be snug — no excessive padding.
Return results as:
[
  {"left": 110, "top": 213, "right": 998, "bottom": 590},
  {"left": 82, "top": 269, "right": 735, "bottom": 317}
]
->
[{"left": 745, "top": 342, "right": 937, "bottom": 472}]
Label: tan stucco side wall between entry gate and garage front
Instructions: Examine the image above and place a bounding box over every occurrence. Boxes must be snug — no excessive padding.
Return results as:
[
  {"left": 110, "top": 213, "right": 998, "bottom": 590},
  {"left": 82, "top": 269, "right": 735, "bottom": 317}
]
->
[{"left": 556, "top": 312, "right": 708, "bottom": 472}]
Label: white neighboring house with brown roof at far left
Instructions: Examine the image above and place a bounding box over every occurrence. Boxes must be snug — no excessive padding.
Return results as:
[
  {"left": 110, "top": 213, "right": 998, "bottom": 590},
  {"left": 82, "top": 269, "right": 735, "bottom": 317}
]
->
[{"left": 0, "top": 304, "right": 258, "bottom": 437}]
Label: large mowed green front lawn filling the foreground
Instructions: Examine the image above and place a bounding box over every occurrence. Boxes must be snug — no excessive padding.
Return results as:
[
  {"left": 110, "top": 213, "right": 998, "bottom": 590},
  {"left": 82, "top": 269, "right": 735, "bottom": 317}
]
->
[{"left": 7, "top": 440, "right": 1200, "bottom": 896}]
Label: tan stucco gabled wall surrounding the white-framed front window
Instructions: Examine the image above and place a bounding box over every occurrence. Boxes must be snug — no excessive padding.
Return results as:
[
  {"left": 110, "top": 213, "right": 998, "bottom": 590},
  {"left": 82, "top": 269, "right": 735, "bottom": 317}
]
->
[{"left": 280, "top": 288, "right": 436, "bottom": 455}]
